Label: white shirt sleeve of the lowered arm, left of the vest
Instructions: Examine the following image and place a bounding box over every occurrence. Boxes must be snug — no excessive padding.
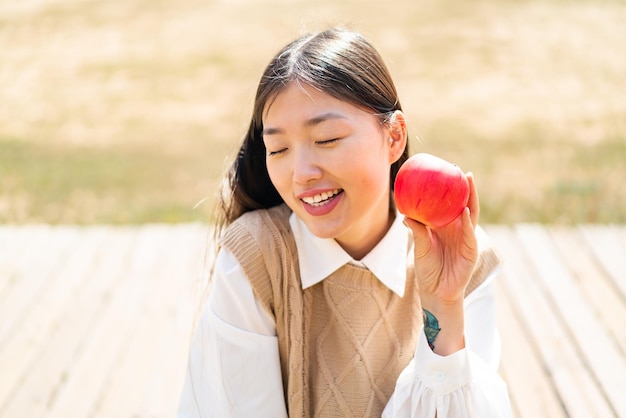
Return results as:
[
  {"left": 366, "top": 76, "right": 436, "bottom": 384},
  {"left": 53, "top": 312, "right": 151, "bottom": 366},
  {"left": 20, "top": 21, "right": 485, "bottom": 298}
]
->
[{"left": 178, "top": 250, "right": 287, "bottom": 418}]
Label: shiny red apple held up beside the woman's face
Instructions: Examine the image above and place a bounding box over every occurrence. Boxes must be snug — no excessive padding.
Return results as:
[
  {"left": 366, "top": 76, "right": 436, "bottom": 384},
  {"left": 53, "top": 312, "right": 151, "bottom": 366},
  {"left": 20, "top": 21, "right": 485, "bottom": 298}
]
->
[{"left": 394, "top": 153, "right": 469, "bottom": 228}]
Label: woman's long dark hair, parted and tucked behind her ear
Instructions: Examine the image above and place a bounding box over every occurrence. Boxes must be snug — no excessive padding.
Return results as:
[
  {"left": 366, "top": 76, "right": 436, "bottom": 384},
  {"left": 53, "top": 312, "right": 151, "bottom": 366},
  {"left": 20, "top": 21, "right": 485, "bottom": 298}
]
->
[{"left": 217, "top": 28, "right": 409, "bottom": 230}]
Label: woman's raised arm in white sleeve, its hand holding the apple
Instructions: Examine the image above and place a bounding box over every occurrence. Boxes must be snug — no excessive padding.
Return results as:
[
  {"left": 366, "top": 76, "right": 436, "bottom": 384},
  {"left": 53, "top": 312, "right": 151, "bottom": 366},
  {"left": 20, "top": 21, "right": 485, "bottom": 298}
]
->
[{"left": 383, "top": 174, "right": 511, "bottom": 418}]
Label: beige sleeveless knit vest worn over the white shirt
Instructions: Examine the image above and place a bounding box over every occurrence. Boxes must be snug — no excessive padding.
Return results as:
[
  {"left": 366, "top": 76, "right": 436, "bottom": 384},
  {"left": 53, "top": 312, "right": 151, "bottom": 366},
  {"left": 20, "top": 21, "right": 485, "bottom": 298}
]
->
[{"left": 221, "top": 205, "right": 498, "bottom": 418}]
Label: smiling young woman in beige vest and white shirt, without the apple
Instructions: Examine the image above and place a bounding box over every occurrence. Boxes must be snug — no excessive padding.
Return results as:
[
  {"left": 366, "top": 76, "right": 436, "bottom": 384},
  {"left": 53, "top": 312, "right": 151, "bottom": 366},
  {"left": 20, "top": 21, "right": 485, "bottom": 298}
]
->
[{"left": 179, "top": 29, "right": 511, "bottom": 418}]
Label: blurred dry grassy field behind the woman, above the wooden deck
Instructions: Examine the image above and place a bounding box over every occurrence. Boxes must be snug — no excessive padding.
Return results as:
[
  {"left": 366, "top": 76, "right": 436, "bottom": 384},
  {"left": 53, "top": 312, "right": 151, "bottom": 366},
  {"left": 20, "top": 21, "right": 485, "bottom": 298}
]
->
[{"left": 0, "top": 0, "right": 626, "bottom": 224}]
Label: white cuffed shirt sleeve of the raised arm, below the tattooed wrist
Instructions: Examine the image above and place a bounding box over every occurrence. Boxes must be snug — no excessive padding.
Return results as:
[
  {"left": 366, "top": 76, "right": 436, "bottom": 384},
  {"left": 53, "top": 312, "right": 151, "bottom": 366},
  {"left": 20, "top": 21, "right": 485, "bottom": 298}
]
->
[{"left": 383, "top": 274, "right": 513, "bottom": 418}]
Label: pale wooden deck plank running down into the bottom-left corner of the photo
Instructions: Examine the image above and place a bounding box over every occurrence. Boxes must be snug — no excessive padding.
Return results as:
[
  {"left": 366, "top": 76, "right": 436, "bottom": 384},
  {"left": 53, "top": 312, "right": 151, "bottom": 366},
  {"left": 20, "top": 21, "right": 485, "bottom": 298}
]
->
[{"left": 0, "top": 228, "right": 137, "bottom": 418}]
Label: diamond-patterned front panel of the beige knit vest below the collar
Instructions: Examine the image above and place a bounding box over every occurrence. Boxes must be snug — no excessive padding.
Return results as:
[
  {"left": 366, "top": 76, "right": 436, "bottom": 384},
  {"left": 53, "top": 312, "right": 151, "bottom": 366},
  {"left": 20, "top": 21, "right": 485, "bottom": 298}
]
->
[{"left": 305, "top": 265, "right": 421, "bottom": 417}]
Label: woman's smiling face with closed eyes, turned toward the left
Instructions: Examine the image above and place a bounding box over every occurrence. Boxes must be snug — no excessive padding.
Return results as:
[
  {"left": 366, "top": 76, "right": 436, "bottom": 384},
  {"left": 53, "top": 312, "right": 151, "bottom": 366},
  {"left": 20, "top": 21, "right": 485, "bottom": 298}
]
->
[{"left": 263, "top": 83, "right": 406, "bottom": 259}]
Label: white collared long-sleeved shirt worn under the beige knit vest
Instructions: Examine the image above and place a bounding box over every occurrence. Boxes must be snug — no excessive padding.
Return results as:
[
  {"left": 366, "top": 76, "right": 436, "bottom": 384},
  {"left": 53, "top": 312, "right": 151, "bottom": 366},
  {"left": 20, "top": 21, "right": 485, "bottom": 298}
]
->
[{"left": 178, "top": 214, "right": 512, "bottom": 418}]
